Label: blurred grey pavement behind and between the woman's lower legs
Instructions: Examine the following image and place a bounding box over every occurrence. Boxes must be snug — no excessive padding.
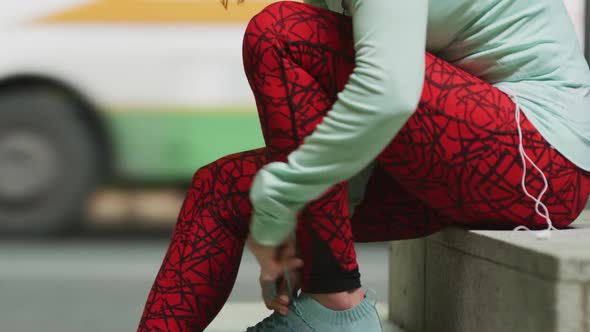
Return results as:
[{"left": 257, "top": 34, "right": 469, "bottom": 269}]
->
[{"left": 0, "top": 238, "right": 398, "bottom": 332}]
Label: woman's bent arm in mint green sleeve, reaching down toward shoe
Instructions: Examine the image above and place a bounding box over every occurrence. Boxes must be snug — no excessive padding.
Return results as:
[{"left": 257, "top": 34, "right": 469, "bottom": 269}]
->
[{"left": 250, "top": 0, "right": 428, "bottom": 246}]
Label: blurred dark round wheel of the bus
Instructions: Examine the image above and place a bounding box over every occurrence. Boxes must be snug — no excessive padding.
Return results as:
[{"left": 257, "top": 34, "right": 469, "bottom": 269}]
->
[{"left": 0, "top": 88, "right": 100, "bottom": 235}]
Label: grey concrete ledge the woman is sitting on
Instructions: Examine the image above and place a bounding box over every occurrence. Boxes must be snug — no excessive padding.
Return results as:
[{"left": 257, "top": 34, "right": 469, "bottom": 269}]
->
[{"left": 389, "top": 210, "right": 590, "bottom": 332}]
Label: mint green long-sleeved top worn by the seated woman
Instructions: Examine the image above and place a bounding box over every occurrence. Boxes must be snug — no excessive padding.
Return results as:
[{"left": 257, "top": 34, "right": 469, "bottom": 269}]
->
[{"left": 250, "top": 0, "right": 590, "bottom": 245}]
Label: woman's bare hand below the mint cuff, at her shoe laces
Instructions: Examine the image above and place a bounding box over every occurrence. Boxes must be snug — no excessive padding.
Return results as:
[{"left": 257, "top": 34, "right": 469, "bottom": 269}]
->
[{"left": 248, "top": 238, "right": 303, "bottom": 315}]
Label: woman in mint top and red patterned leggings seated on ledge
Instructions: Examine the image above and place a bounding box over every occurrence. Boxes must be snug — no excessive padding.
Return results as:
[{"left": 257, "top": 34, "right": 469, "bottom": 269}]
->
[{"left": 139, "top": 0, "right": 590, "bottom": 331}]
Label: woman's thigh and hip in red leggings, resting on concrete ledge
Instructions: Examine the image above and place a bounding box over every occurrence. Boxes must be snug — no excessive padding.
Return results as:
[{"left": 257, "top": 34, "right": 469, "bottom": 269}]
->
[{"left": 378, "top": 54, "right": 590, "bottom": 228}]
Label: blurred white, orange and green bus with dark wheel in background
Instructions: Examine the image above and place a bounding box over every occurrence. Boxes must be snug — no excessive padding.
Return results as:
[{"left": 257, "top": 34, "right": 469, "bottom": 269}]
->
[{"left": 0, "top": 0, "right": 586, "bottom": 234}]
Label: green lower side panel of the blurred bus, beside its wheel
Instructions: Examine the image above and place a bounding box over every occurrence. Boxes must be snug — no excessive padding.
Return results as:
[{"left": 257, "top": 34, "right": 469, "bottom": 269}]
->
[{"left": 106, "top": 111, "right": 264, "bottom": 183}]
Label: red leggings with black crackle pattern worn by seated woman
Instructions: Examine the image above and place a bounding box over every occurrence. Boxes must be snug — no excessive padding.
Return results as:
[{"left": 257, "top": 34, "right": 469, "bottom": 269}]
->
[{"left": 139, "top": 2, "right": 590, "bottom": 331}]
